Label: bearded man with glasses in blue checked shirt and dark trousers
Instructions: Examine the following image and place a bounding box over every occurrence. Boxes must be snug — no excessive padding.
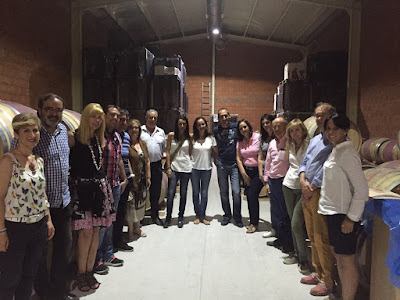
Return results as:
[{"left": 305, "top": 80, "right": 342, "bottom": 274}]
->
[{"left": 23, "top": 93, "right": 76, "bottom": 300}]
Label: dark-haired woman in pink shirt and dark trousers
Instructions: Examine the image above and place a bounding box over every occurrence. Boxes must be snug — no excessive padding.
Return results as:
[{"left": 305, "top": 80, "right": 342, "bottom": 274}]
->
[{"left": 236, "top": 119, "right": 263, "bottom": 233}]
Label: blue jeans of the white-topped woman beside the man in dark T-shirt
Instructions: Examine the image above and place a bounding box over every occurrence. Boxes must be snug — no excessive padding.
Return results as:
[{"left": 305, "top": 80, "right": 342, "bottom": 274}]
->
[{"left": 192, "top": 169, "right": 211, "bottom": 218}]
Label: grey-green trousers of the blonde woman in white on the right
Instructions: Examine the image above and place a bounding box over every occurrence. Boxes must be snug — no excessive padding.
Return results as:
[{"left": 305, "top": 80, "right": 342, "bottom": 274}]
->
[{"left": 282, "top": 186, "right": 311, "bottom": 264}]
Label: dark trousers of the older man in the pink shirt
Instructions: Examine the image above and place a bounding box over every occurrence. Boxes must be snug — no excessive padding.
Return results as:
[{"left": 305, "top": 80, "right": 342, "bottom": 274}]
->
[{"left": 268, "top": 177, "right": 293, "bottom": 247}]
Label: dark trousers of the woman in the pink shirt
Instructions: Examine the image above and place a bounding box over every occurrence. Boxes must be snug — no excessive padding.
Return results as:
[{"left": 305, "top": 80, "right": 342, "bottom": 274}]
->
[{"left": 244, "top": 167, "right": 263, "bottom": 227}]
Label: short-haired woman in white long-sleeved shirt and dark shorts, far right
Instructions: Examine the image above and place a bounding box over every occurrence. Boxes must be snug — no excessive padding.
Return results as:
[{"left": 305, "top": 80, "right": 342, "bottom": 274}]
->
[{"left": 318, "top": 115, "right": 368, "bottom": 300}]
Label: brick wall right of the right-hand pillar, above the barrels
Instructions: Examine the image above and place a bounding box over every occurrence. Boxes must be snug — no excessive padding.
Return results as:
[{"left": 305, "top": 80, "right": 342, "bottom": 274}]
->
[{"left": 358, "top": 0, "right": 400, "bottom": 138}]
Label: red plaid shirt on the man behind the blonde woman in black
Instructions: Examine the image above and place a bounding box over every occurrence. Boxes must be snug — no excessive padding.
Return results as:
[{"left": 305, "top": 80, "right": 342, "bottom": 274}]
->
[{"left": 103, "top": 132, "right": 122, "bottom": 188}]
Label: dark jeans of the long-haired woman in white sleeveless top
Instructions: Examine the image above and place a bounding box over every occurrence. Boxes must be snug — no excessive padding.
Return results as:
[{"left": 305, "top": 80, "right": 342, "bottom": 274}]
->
[{"left": 166, "top": 171, "right": 192, "bottom": 220}]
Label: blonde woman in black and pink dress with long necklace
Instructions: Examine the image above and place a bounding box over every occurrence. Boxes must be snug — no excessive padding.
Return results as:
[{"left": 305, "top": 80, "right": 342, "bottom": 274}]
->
[{"left": 68, "top": 103, "right": 115, "bottom": 292}]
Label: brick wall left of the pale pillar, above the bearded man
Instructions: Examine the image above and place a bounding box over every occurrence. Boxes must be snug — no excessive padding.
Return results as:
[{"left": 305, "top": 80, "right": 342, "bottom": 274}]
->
[{"left": 0, "top": 0, "right": 71, "bottom": 108}]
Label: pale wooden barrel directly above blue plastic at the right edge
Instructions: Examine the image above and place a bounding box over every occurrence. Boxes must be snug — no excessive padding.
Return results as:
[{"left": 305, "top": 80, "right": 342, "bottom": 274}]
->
[{"left": 364, "top": 167, "right": 400, "bottom": 194}]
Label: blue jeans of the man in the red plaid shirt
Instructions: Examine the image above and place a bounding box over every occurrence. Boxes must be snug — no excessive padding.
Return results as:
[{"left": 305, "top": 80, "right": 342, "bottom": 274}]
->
[{"left": 95, "top": 185, "right": 121, "bottom": 265}]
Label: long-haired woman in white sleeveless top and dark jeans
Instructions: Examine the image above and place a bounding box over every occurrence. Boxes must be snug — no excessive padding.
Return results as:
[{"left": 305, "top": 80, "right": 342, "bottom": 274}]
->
[{"left": 164, "top": 115, "right": 192, "bottom": 228}]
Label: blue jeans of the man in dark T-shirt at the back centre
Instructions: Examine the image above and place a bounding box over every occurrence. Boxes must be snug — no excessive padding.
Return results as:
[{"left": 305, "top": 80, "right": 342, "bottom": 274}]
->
[{"left": 217, "top": 161, "right": 242, "bottom": 222}]
